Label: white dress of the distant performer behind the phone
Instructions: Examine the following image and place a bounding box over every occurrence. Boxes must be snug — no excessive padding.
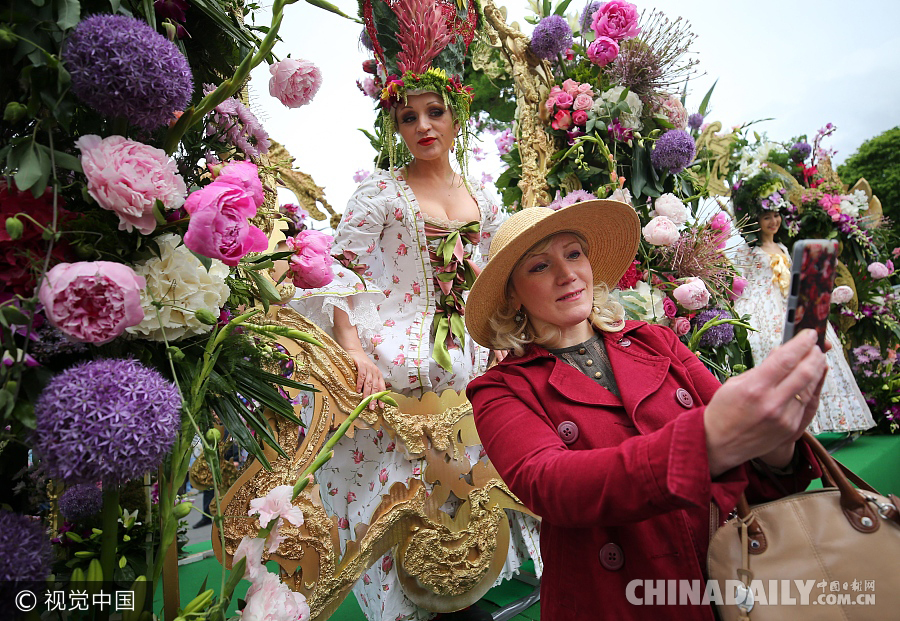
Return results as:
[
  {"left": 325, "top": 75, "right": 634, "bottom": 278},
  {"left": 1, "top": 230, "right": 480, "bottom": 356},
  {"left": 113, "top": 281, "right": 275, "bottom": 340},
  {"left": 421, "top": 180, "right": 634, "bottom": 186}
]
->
[{"left": 734, "top": 244, "right": 875, "bottom": 434}]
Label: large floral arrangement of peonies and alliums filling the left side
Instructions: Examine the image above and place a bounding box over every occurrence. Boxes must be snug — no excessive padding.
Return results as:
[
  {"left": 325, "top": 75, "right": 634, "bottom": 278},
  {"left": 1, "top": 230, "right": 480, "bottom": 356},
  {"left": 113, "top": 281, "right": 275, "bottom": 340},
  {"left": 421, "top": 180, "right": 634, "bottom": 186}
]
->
[{"left": 0, "top": 0, "right": 356, "bottom": 619}]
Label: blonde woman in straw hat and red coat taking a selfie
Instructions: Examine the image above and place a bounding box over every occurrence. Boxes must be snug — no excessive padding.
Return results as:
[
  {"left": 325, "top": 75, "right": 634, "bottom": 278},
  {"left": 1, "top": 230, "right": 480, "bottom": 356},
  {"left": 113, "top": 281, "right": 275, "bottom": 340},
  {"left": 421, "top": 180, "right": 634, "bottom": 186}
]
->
[{"left": 465, "top": 201, "right": 826, "bottom": 621}]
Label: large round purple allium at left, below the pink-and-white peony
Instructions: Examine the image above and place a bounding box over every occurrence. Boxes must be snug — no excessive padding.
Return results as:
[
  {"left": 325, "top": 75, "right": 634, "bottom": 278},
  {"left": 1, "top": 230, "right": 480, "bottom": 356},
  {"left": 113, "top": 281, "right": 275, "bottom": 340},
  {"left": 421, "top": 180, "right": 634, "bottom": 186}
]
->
[{"left": 34, "top": 359, "right": 181, "bottom": 485}]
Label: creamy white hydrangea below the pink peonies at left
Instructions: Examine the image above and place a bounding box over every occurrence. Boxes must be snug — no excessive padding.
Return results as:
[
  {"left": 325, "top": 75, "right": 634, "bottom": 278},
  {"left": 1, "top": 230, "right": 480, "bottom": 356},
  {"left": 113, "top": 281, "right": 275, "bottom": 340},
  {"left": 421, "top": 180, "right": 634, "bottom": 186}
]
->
[{"left": 128, "top": 233, "right": 230, "bottom": 341}]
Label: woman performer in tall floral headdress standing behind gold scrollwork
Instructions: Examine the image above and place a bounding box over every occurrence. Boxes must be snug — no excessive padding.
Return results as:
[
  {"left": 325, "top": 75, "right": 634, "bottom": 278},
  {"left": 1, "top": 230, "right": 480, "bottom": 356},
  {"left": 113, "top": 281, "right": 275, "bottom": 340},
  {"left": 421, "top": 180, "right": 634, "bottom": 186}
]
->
[{"left": 291, "top": 2, "right": 541, "bottom": 621}]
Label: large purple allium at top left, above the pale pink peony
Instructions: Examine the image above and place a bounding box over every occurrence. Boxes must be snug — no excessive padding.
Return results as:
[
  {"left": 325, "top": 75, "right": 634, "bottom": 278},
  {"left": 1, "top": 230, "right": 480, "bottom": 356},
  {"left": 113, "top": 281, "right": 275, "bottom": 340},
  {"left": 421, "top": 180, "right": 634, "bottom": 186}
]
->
[{"left": 63, "top": 15, "right": 193, "bottom": 130}]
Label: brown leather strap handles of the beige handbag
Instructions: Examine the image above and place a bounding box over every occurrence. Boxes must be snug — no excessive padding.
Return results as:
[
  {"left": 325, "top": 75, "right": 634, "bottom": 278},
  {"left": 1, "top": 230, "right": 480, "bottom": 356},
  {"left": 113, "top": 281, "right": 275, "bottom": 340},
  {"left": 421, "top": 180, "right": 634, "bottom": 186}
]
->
[{"left": 737, "top": 431, "right": 897, "bottom": 554}]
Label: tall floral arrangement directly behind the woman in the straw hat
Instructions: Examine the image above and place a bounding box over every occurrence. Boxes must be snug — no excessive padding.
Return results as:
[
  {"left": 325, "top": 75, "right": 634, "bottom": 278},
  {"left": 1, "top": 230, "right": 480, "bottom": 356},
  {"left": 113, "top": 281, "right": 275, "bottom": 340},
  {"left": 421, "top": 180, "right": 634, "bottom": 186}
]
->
[{"left": 488, "top": 0, "right": 749, "bottom": 379}]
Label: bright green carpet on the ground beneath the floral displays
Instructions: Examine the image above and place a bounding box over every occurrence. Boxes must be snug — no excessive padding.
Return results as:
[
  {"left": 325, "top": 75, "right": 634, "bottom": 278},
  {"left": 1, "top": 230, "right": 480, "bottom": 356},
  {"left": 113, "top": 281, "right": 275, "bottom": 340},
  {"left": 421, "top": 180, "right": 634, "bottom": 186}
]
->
[{"left": 154, "top": 434, "right": 900, "bottom": 621}]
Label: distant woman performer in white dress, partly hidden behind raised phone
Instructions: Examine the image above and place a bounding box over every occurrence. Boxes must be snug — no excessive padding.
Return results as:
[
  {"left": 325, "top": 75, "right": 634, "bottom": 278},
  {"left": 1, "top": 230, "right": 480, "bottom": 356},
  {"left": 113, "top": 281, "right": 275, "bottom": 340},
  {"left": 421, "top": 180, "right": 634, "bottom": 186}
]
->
[{"left": 734, "top": 170, "right": 875, "bottom": 434}]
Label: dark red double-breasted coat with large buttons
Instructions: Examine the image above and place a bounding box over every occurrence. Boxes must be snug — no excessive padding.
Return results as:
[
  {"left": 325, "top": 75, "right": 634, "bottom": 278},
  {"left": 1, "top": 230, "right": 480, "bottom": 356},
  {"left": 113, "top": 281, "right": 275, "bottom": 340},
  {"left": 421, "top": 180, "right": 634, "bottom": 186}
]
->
[{"left": 467, "top": 321, "right": 815, "bottom": 621}]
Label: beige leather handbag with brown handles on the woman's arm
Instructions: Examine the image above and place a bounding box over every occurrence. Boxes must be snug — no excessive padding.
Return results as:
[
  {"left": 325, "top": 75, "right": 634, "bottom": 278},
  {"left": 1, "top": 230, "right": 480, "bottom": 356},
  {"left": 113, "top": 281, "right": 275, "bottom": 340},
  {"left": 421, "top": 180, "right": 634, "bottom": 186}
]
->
[{"left": 707, "top": 433, "right": 900, "bottom": 621}]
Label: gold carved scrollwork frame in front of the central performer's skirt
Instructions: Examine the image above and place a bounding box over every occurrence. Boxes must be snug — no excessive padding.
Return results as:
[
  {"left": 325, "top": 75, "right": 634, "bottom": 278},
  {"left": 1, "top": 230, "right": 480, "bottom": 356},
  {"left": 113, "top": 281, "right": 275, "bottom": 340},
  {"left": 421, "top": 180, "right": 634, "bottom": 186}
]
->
[{"left": 212, "top": 307, "right": 532, "bottom": 621}]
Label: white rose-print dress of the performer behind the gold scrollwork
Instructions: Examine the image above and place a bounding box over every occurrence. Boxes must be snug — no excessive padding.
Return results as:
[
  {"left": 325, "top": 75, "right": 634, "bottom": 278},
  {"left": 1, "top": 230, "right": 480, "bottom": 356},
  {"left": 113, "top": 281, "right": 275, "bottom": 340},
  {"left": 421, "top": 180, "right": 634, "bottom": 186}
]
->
[{"left": 291, "top": 170, "right": 542, "bottom": 621}]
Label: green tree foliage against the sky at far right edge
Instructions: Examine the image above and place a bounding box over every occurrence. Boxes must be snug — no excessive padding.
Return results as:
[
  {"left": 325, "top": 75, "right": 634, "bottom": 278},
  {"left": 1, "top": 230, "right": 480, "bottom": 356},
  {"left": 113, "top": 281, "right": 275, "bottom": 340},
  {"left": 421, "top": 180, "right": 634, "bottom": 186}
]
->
[{"left": 838, "top": 126, "right": 900, "bottom": 221}]
